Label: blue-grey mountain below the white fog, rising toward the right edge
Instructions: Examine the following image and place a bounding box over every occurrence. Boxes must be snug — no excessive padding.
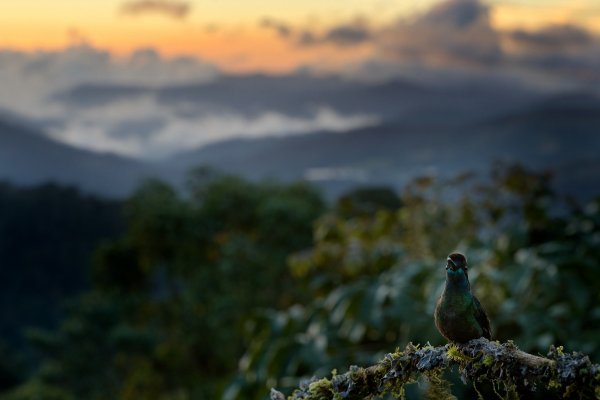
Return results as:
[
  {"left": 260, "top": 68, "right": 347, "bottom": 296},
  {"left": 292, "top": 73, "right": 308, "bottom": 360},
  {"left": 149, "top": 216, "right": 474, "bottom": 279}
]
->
[{"left": 169, "top": 95, "right": 600, "bottom": 197}]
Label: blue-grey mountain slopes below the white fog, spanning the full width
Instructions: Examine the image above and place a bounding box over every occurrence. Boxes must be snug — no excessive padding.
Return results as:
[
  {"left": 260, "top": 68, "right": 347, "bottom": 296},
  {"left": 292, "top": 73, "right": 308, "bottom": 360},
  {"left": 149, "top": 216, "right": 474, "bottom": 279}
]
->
[{"left": 0, "top": 93, "right": 600, "bottom": 197}]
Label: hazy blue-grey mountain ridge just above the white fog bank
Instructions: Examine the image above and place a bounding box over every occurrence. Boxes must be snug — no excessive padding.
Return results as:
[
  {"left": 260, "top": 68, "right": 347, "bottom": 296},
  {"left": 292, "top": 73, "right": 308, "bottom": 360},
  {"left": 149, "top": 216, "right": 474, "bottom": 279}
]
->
[{"left": 52, "top": 73, "right": 537, "bottom": 121}]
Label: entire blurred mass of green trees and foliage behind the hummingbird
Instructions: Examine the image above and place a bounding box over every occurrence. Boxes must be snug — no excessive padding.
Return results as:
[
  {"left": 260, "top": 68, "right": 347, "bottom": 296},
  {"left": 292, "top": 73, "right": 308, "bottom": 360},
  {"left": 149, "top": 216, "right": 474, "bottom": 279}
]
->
[{"left": 2, "top": 165, "right": 600, "bottom": 400}]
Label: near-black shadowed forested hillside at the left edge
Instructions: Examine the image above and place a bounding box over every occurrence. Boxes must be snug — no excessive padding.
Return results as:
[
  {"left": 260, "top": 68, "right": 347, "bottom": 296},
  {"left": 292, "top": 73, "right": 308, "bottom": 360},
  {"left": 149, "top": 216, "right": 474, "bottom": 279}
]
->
[{"left": 0, "top": 183, "right": 124, "bottom": 387}]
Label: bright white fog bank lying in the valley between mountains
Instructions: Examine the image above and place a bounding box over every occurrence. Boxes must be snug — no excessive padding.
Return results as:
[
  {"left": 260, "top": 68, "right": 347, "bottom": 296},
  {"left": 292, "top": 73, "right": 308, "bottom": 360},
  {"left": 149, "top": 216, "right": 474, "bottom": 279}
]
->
[{"left": 50, "top": 95, "right": 379, "bottom": 159}]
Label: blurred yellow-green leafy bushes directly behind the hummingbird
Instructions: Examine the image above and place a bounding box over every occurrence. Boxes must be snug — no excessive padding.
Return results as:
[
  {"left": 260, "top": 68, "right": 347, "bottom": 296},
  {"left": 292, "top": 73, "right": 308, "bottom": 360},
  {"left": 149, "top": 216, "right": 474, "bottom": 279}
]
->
[{"left": 230, "top": 166, "right": 600, "bottom": 398}]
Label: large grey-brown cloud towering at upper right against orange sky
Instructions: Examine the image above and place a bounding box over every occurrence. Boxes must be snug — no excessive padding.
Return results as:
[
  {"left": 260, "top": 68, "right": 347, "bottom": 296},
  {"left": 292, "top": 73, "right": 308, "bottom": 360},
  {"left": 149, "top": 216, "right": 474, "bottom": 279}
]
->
[{"left": 332, "top": 0, "right": 600, "bottom": 92}]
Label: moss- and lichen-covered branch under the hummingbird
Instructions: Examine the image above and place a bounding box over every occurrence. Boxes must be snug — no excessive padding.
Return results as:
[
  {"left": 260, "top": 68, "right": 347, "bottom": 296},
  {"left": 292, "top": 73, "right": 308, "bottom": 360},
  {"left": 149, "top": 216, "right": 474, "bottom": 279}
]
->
[{"left": 271, "top": 338, "right": 600, "bottom": 400}]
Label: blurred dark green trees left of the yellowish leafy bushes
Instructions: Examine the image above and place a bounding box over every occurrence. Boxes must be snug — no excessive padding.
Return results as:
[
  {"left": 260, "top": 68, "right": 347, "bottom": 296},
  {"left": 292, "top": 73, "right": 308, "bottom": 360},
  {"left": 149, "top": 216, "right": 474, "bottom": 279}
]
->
[{"left": 7, "top": 171, "right": 324, "bottom": 400}]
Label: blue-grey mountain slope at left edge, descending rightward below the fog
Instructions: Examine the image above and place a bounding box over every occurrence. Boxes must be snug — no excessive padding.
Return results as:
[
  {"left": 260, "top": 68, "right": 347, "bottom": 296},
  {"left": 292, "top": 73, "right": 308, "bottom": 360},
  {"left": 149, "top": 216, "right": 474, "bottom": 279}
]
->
[{"left": 0, "top": 120, "right": 156, "bottom": 197}]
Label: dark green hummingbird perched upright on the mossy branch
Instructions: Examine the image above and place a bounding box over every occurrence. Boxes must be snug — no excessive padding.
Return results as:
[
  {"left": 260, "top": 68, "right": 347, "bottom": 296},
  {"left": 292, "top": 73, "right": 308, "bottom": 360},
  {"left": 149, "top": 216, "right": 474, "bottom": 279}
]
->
[{"left": 434, "top": 253, "right": 491, "bottom": 343}]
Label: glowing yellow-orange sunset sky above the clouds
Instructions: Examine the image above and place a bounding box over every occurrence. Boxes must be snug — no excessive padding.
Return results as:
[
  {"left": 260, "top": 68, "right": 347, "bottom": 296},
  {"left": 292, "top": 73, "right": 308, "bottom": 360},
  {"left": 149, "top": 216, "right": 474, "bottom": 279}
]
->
[{"left": 0, "top": 0, "right": 600, "bottom": 72}]
